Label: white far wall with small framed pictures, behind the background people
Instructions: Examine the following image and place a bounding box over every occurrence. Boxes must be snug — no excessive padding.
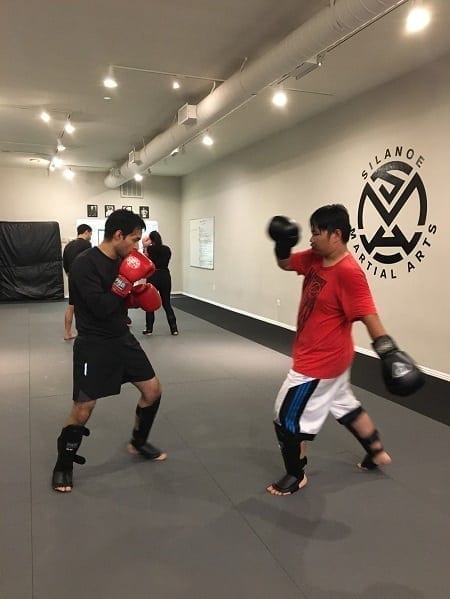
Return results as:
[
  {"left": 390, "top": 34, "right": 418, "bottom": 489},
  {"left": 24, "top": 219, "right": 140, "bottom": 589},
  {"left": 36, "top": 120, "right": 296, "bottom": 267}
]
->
[{"left": 0, "top": 168, "right": 181, "bottom": 290}]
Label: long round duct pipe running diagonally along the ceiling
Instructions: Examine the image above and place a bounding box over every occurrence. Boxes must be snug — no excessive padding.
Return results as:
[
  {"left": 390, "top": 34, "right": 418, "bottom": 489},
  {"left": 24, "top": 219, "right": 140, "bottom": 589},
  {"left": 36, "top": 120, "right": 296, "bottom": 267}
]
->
[{"left": 105, "top": 0, "right": 407, "bottom": 188}]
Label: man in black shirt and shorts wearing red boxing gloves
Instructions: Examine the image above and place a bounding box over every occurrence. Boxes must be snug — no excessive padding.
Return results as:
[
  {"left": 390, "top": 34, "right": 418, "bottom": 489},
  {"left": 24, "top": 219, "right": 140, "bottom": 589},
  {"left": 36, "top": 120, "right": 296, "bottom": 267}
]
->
[{"left": 52, "top": 210, "right": 167, "bottom": 493}]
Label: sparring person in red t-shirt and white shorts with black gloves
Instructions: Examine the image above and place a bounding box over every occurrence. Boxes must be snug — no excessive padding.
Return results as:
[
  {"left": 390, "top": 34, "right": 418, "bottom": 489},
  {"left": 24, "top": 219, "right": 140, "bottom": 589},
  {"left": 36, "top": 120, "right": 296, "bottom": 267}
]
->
[{"left": 267, "top": 204, "right": 423, "bottom": 495}]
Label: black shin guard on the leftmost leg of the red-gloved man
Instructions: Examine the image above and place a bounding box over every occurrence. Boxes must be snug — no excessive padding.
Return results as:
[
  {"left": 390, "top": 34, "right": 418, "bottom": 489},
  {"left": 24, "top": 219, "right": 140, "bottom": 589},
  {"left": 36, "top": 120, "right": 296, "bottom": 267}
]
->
[{"left": 52, "top": 424, "right": 89, "bottom": 488}]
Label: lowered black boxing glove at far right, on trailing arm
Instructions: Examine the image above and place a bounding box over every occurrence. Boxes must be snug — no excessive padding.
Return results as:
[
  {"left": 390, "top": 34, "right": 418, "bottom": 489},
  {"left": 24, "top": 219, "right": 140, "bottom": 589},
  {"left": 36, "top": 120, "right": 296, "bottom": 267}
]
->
[{"left": 372, "top": 335, "right": 425, "bottom": 397}]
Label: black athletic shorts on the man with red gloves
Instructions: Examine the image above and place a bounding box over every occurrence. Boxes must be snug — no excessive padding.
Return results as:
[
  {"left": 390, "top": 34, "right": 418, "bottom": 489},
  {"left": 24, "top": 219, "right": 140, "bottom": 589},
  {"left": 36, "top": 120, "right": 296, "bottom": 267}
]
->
[{"left": 72, "top": 332, "right": 155, "bottom": 402}]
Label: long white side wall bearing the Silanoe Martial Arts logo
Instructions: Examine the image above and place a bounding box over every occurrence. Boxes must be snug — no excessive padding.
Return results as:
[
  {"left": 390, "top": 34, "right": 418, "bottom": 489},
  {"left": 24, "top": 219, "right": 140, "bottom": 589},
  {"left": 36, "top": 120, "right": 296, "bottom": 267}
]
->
[{"left": 182, "top": 57, "right": 450, "bottom": 373}]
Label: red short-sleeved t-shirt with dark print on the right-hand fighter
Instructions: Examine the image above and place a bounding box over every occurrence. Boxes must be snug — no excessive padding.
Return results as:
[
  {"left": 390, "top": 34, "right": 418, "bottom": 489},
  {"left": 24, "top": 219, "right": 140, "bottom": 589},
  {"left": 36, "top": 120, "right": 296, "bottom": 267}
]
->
[{"left": 289, "top": 250, "right": 377, "bottom": 379}]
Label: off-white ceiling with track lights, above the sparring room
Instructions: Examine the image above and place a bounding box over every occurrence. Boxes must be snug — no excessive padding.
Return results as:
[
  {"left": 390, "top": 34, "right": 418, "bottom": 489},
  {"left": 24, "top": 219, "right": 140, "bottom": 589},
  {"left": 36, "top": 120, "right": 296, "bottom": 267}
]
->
[{"left": 0, "top": 0, "right": 450, "bottom": 176}]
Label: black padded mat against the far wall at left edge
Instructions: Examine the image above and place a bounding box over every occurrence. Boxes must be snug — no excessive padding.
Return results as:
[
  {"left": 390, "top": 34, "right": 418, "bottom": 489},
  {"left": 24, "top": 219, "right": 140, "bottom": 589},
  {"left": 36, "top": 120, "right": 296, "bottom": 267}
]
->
[{"left": 0, "top": 221, "right": 64, "bottom": 302}]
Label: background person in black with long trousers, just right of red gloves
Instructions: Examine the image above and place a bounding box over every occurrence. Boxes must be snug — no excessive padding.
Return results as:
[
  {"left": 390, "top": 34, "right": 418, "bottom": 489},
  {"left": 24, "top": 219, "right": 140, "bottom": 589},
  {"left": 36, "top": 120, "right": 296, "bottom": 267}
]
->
[{"left": 142, "top": 231, "right": 178, "bottom": 335}]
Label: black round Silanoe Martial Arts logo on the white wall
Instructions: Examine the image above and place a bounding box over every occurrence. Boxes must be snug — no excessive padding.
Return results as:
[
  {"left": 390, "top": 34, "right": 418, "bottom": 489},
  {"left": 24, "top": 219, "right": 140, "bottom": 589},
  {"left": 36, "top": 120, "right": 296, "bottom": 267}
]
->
[{"left": 351, "top": 146, "right": 437, "bottom": 279}]
